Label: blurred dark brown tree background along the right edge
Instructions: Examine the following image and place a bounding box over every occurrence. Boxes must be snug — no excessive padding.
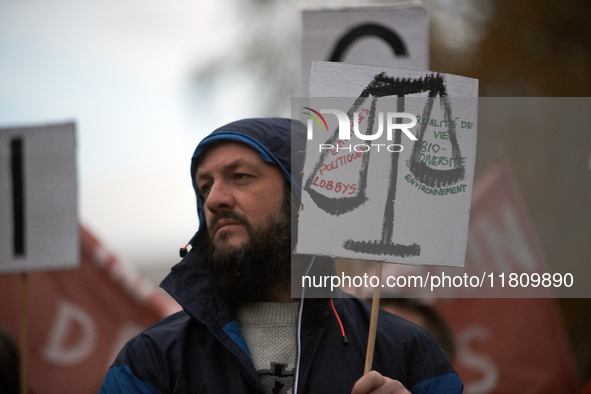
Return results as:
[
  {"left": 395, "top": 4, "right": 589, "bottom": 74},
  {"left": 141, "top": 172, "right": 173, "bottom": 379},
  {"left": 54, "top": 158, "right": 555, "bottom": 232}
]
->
[{"left": 431, "top": 0, "right": 591, "bottom": 381}]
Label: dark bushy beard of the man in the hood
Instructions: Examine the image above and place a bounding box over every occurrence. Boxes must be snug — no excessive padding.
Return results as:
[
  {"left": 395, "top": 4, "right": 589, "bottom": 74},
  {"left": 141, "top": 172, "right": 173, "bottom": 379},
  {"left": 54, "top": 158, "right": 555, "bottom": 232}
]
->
[{"left": 209, "top": 191, "right": 291, "bottom": 304}]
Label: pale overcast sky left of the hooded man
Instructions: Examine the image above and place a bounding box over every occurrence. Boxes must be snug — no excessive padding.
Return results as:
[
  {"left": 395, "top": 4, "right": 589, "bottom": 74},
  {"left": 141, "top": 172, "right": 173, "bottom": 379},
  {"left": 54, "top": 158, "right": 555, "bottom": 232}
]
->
[{"left": 0, "top": 0, "right": 248, "bottom": 265}]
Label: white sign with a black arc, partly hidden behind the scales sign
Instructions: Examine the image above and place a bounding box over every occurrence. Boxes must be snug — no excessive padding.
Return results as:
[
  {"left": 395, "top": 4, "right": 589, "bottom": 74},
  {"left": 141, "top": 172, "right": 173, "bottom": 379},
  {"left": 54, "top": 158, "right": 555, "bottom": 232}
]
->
[{"left": 302, "top": 3, "right": 429, "bottom": 95}]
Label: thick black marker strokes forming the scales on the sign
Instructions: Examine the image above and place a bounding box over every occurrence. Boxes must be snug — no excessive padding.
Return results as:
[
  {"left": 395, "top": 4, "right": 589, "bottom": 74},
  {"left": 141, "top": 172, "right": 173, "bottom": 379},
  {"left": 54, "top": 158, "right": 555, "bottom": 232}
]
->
[{"left": 304, "top": 73, "right": 465, "bottom": 257}]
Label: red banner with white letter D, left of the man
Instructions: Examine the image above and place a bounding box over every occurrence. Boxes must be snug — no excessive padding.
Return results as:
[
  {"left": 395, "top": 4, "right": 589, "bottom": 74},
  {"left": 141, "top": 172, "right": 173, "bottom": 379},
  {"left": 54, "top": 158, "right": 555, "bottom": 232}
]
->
[{"left": 0, "top": 228, "right": 180, "bottom": 394}]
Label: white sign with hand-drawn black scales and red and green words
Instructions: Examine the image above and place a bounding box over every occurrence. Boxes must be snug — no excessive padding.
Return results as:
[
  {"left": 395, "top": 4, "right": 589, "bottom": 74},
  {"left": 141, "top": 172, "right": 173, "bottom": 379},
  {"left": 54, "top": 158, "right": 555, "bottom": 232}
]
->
[{"left": 292, "top": 62, "right": 478, "bottom": 266}]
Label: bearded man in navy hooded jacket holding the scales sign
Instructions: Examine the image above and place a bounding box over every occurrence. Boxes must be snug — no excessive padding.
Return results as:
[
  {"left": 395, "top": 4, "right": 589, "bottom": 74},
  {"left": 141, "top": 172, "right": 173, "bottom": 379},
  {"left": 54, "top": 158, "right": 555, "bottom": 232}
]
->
[{"left": 101, "top": 118, "right": 462, "bottom": 394}]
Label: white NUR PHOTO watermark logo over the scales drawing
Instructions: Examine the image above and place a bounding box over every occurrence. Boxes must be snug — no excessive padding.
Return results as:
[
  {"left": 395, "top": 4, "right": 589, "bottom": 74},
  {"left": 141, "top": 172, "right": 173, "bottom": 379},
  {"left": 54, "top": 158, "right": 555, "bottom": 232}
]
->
[{"left": 302, "top": 107, "right": 417, "bottom": 152}]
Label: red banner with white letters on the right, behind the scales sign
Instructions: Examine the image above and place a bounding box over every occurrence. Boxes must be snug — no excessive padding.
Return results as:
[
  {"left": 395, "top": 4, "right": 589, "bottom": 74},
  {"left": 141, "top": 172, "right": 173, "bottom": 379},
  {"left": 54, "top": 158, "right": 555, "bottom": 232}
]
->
[{"left": 436, "top": 163, "right": 579, "bottom": 394}]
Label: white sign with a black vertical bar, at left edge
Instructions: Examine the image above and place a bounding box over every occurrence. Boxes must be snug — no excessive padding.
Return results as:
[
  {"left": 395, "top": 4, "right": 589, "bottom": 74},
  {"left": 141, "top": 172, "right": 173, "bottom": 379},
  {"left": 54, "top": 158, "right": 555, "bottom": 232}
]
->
[{"left": 0, "top": 123, "right": 79, "bottom": 273}]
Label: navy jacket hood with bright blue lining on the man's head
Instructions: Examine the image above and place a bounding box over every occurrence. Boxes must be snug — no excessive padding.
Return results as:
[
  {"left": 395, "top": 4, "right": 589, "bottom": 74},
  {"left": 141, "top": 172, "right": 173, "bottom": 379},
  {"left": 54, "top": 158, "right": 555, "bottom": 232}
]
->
[{"left": 190, "top": 118, "right": 306, "bottom": 246}]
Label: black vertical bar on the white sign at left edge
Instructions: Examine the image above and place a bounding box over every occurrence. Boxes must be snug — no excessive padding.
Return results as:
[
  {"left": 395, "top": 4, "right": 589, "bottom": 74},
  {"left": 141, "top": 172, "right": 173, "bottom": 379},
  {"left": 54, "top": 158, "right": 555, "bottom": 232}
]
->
[{"left": 10, "top": 138, "right": 25, "bottom": 256}]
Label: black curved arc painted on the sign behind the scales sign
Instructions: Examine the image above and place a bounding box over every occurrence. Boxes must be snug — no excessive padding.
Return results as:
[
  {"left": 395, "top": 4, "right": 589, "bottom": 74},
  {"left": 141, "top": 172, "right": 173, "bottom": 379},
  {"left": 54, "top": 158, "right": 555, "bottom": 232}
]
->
[{"left": 328, "top": 23, "right": 408, "bottom": 62}]
